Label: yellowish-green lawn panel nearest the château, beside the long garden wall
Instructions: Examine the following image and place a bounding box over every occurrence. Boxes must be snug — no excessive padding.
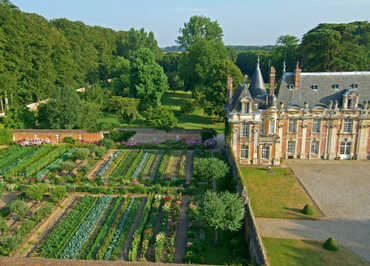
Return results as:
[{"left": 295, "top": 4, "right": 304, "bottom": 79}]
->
[{"left": 241, "top": 168, "right": 321, "bottom": 219}]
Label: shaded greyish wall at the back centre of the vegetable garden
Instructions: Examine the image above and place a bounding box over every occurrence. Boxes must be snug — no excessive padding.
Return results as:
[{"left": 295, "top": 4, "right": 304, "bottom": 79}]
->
[{"left": 116, "top": 128, "right": 202, "bottom": 144}]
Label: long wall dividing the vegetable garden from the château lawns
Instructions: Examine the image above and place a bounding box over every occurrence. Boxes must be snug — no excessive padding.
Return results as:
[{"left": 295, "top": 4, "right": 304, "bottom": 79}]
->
[{"left": 226, "top": 146, "right": 269, "bottom": 266}]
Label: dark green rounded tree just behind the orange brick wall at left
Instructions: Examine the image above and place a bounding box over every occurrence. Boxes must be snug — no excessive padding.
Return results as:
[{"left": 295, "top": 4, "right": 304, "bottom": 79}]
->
[{"left": 38, "top": 87, "right": 81, "bottom": 129}]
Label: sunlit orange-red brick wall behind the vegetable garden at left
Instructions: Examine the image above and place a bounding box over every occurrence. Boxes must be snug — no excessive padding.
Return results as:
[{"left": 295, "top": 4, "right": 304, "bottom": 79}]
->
[{"left": 13, "top": 129, "right": 104, "bottom": 143}]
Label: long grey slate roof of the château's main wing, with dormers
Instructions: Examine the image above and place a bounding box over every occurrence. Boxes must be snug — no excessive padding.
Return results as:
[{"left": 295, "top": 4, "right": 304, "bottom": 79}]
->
[{"left": 276, "top": 71, "right": 370, "bottom": 107}]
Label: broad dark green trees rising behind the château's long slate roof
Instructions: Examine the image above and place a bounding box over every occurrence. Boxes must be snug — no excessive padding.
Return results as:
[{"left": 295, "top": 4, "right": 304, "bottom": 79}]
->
[{"left": 301, "top": 21, "right": 370, "bottom": 71}]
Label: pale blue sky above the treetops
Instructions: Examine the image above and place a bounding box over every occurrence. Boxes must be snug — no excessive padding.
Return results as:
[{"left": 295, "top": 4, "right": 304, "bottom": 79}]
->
[{"left": 11, "top": 0, "right": 370, "bottom": 47}]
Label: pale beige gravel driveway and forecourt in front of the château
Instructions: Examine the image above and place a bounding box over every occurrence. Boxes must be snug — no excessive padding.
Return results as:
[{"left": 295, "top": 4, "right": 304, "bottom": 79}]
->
[{"left": 257, "top": 160, "right": 370, "bottom": 262}]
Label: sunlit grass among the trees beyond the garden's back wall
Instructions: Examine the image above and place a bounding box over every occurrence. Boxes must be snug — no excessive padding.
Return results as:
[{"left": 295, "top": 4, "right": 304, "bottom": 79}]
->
[{"left": 99, "top": 91, "right": 224, "bottom": 133}]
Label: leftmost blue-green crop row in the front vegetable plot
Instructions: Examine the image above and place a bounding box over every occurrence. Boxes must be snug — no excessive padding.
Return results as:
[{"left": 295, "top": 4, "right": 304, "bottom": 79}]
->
[{"left": 60, "top": 196, "right": 112, "bottom": 259}]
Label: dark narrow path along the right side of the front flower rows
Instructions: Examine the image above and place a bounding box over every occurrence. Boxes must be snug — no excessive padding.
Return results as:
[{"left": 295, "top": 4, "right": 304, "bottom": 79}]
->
[{"left": 174, "top": 196, "right": 190, "bottom": 263}]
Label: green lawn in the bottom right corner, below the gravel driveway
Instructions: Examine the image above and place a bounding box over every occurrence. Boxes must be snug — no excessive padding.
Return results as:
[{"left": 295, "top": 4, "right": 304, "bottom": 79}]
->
[{"left": 262, "top": 238, "right": 369, "bottom": 266}]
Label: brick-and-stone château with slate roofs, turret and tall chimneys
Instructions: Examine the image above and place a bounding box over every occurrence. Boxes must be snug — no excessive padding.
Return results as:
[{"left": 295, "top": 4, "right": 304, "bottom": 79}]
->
[{"left": 226, "top": 59, "right": 370, "bottom": 166}]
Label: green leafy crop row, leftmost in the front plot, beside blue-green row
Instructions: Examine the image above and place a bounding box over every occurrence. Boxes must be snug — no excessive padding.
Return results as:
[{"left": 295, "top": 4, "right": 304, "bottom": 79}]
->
[{"left": 40, "top": 196, "right": 97, "bottom": 258}]
